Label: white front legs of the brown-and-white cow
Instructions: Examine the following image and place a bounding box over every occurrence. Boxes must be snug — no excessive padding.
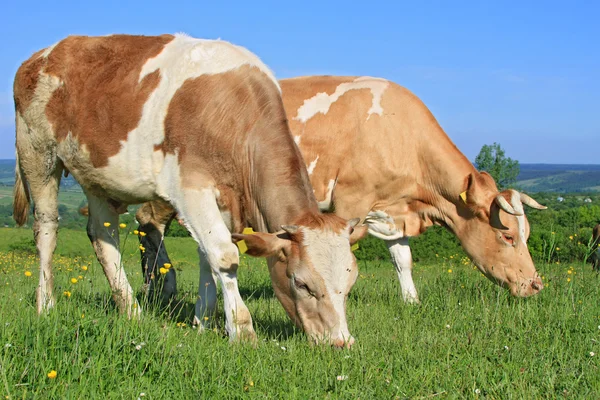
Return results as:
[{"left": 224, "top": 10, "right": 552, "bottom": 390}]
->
[{"left": 178, "top": 188, "right": 256, "bottom": 341}]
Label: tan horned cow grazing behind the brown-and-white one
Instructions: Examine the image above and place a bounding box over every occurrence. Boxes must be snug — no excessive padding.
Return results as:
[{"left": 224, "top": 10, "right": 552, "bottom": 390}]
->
[{"left": 132, "top": 76, "right": 546, "bottom": 302}]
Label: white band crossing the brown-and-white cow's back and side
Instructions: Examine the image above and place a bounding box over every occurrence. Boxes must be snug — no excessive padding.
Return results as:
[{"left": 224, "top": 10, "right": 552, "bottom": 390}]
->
[{"left": 103, "top": 35, "right": 279, "bottom": 197}]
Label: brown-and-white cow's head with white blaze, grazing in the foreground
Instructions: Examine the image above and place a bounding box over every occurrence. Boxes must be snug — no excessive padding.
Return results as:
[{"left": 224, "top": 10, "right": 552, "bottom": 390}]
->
[{"left": 233, "top": 215, "right": 367, "bottom": 347}]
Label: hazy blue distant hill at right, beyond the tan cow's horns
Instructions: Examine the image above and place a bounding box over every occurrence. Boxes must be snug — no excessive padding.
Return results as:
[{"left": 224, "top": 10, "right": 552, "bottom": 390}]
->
[{"left": 517, "top": 164, "right": 600, "bottom": 193}]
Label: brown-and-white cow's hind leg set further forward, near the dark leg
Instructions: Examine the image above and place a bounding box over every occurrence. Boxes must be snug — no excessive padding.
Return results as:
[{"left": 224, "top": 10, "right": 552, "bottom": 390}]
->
[{"left": 87, "top": 195, "right": 141, "bottom": 318}]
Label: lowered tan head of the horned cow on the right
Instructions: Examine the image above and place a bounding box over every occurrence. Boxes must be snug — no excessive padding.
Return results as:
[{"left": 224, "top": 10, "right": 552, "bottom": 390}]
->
[{"left": 457, "top": 172, "right": 546, "bottom": 297}]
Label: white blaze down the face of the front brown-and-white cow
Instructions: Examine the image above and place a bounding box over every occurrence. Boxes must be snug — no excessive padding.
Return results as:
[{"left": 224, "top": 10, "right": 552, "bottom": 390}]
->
[{"left": 302, "top": 229, "right": 356, "bottom": 339}]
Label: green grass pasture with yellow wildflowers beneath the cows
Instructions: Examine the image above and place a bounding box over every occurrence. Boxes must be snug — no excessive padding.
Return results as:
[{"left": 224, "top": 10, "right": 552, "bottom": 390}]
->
[{"left": 0, "top": 228, "right": 600, "bottom": 399}]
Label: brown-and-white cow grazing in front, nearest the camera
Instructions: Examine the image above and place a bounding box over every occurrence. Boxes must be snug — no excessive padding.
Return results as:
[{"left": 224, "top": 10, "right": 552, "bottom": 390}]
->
[{"left": 14, "top": 35, "right": 366, "bottom": 346}]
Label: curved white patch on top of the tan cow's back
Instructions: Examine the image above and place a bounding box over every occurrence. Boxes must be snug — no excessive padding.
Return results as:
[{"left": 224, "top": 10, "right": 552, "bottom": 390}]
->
[{"left": 294, "top": 76, "right": 389, "bottom": 123}]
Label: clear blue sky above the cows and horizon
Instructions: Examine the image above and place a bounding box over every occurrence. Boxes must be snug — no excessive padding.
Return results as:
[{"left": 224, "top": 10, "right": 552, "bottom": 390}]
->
[{"left": 0, "top": 0, "right": 600, "bottom": 164}]
